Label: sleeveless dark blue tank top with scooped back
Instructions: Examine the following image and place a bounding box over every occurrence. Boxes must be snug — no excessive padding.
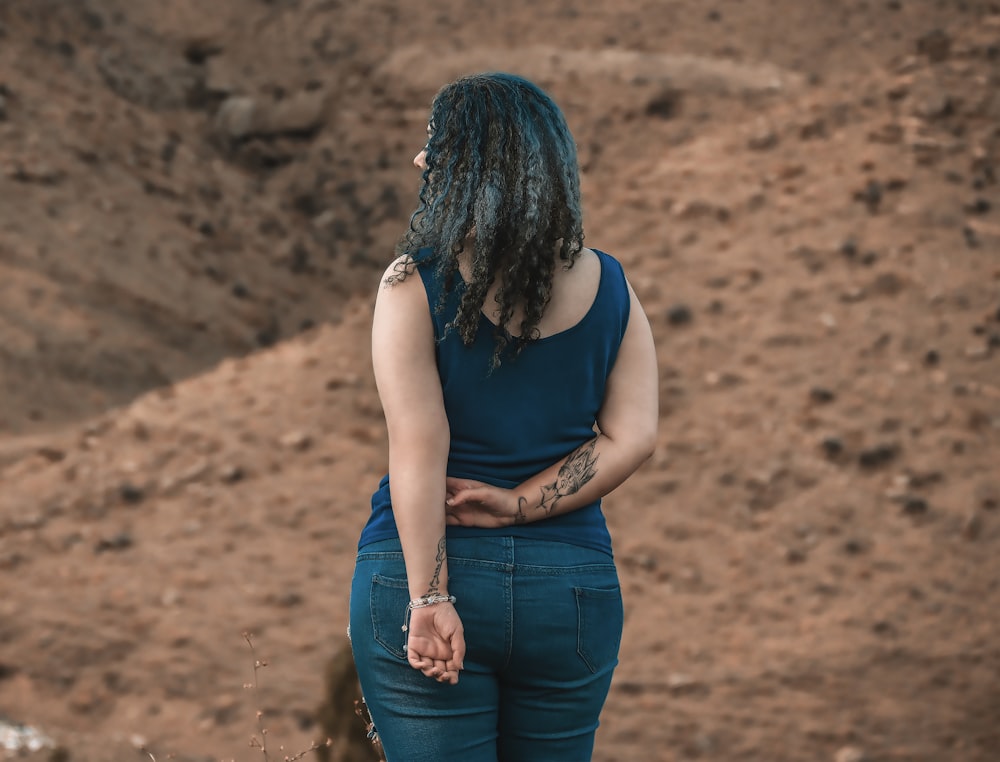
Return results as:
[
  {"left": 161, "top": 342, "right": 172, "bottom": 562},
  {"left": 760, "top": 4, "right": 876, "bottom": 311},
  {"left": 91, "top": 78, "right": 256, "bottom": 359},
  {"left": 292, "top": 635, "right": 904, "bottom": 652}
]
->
[{"left": 358, "top": 249, "right": 629, "bottom": 553}]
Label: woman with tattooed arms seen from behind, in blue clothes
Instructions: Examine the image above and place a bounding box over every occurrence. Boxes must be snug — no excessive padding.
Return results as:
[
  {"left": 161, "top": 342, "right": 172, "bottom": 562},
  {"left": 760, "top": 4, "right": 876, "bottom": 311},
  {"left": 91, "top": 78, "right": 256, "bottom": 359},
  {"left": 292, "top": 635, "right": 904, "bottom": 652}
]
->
[{"left": 351, "top": 74, "right": 658, "bottom": 762}]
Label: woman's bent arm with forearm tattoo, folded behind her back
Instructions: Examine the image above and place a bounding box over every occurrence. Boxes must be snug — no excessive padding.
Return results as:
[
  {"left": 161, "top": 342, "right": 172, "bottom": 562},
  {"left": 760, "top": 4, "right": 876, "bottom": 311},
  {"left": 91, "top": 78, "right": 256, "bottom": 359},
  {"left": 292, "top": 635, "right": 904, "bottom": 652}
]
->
[{"left": 447, "top": 276, "right": 659, "bottom": 527}]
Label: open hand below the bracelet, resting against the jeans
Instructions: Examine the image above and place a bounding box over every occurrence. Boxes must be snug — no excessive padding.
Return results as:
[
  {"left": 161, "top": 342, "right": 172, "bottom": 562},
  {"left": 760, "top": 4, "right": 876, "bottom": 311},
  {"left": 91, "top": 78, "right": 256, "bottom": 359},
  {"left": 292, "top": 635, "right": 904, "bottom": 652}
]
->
[{"left": 406, "top": 603, "right": 465, "bottom": 685}]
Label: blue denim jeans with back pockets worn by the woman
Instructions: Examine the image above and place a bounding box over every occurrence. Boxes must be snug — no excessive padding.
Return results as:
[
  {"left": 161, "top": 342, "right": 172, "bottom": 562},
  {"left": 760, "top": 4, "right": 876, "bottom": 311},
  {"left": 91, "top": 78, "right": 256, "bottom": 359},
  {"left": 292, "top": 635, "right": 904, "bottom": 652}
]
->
[{"left": 351, "top": 537, "right": 623, "bottom": 762}]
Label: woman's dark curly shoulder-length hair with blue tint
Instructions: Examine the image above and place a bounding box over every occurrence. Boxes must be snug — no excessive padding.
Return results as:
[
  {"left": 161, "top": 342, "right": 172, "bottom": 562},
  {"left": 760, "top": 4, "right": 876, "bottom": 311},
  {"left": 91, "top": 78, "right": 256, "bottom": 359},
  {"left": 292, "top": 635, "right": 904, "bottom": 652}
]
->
[{"left": 394, "top": 73, "right": 583, "bottom": 368}]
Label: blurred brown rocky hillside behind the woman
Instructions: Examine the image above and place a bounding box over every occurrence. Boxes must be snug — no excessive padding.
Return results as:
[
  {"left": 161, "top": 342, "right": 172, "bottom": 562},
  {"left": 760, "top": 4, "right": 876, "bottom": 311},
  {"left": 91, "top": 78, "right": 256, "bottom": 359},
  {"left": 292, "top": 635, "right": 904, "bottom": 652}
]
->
[{"left": 0, "top": 0, "right": 1000, "bottom": 762}]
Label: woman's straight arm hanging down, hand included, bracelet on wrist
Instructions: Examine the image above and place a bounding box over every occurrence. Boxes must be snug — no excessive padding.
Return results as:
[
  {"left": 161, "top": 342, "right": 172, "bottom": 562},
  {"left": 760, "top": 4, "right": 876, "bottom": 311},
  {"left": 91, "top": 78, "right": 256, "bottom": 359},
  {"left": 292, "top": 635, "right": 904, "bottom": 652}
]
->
[{"left": 372, "top": 261, "right": 465, "bottom": 683}]
